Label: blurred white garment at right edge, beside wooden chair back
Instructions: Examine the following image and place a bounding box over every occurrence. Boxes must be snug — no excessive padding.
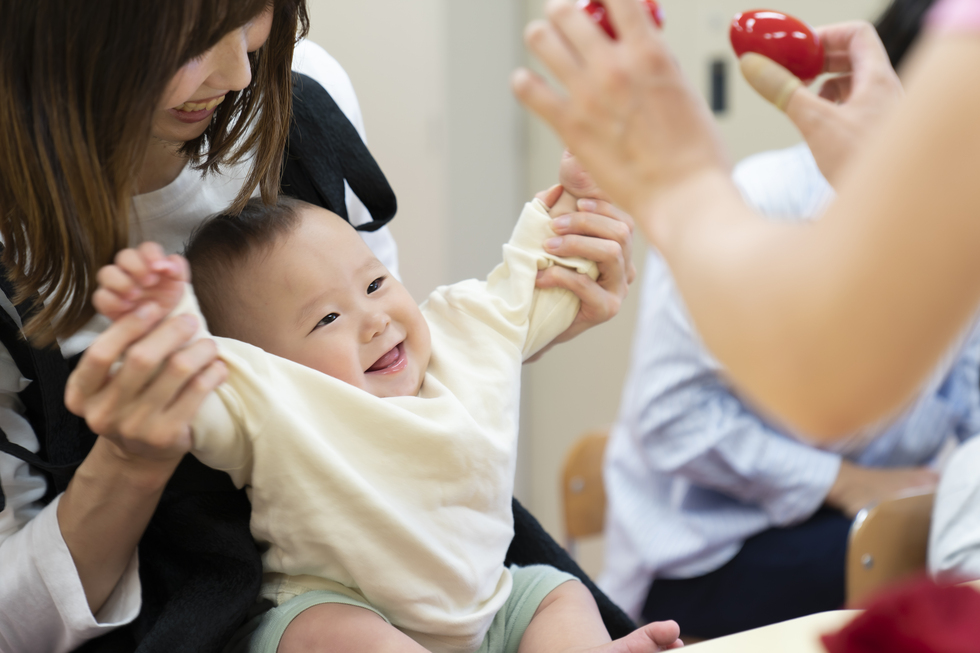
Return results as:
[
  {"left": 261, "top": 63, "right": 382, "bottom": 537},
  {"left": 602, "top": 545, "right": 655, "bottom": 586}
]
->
[{"left": 929, "top": 438, "right": 980, "bottom": 582}]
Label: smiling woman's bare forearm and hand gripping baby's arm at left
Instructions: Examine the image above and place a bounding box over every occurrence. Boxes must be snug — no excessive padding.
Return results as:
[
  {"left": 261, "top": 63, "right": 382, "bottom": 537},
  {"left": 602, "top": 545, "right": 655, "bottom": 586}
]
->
[{"left": 58, "top": 298, "right": 226, "bottom": 612}]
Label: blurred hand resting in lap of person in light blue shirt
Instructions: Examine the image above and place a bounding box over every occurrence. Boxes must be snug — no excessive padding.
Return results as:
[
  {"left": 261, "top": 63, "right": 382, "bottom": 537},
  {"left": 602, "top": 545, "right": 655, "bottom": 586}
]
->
[{"left": 825, "top": 460, "right": 939, "bottom": 517}]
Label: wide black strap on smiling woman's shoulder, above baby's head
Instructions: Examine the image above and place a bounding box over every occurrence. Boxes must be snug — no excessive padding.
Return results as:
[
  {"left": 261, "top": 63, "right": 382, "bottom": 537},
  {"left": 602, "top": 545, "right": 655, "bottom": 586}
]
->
[{"left": 282, "top": 73, "right": 398, "bottom": 231}]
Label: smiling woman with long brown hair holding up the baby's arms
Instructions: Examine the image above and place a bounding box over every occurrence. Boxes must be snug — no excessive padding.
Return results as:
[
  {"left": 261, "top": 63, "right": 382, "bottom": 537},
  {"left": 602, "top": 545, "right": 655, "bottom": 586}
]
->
[{"left": 0, "top": 0, "right": 626, "bottom": 651}]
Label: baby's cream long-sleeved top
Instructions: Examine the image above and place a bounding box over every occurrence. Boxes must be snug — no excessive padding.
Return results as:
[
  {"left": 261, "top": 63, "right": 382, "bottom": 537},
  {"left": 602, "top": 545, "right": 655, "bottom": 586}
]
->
[{"left": 185, "top": 197, "right": 597, "bottom": 651}]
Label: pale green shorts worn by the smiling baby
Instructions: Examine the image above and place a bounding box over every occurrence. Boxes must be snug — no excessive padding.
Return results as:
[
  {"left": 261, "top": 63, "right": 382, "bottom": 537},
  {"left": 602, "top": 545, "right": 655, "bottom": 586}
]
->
[{"left": 248, "top": 565, "right": 578, "bottom": 653}]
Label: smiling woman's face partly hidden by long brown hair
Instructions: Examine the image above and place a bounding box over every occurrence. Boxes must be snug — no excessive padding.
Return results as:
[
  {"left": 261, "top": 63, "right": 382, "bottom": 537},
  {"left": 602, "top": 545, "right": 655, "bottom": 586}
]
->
[{"left": 151, "top": 5, "right": 272, "bottom": 143}]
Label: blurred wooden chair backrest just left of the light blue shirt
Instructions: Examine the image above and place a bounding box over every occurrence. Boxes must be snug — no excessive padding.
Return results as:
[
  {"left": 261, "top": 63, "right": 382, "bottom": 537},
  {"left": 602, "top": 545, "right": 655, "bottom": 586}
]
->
[{"left": 561, "top": 430, "right": 609, "bottom": 555}]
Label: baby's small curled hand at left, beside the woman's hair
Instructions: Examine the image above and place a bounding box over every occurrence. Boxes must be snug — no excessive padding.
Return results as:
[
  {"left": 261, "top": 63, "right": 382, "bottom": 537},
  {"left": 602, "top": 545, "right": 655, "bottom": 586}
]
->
[{"left": 92, "top": 243, "right": 190, "bottom": 322}]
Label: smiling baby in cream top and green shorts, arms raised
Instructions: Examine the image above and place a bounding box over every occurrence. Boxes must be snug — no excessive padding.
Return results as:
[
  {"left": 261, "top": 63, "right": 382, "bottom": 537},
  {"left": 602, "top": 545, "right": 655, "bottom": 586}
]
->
[{"left": 94, "top": 178, "right": 680, "bottom": 653}]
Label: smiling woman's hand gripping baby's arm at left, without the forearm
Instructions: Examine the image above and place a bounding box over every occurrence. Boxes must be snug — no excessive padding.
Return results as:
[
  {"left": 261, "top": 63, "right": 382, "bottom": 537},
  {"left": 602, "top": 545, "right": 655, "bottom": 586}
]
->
[{"left": 65, "top": 303, "right": 227, "bottom": 467}]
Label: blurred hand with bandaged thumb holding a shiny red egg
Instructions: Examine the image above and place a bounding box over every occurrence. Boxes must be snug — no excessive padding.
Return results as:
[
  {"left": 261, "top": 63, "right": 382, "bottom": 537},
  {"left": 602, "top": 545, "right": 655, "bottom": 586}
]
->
[{"left": 741, "top": 21, "right": 905, "bottom": 186}]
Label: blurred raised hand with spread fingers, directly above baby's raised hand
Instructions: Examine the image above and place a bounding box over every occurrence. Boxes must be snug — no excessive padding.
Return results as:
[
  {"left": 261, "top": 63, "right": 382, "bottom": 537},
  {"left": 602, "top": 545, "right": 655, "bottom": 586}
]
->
[{"left": 513, "top": 0, "right": 729, "bottom": 220}]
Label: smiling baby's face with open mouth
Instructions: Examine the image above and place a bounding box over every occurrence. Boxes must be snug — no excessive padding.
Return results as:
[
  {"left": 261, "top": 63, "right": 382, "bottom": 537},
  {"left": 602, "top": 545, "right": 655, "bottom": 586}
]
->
[{"left": 237, "top": 208, "right": 430, "bottom": 397}]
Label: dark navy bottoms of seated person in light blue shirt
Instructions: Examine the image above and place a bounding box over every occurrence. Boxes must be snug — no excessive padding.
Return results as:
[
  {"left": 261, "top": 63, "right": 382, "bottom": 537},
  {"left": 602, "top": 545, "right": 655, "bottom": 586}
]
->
[{"left": 643, "top": 508, "right": 851, "bottom": 637}]
